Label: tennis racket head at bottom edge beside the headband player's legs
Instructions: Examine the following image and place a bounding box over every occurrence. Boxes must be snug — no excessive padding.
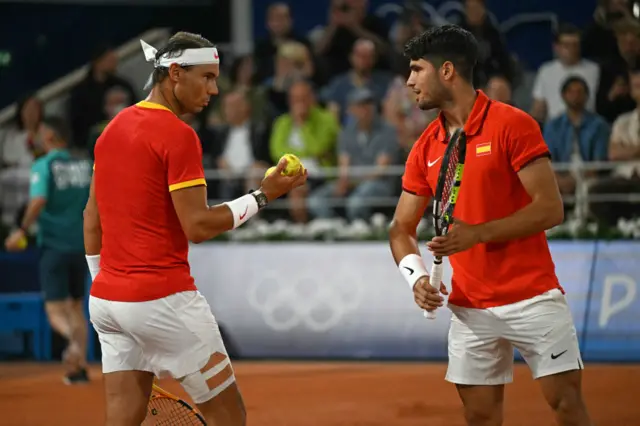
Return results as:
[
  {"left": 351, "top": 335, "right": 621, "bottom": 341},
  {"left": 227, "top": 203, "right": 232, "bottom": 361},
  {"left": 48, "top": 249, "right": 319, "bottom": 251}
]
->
[{"left": 141, "top": 383, "right": 207, "bottom": 426}]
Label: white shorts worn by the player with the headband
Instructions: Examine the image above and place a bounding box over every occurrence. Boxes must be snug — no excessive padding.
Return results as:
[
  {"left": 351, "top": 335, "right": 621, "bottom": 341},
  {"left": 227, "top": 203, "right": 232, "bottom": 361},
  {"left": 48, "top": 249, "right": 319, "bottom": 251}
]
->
[{"left": 89, "top": 291, "right": 228, "bottom": 379}]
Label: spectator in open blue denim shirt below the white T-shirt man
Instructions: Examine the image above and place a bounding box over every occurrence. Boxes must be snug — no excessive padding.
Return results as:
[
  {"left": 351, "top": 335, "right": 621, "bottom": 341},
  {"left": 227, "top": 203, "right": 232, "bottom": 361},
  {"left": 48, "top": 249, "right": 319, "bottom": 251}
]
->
[{"left": 544, "top": 76, "right": 610, "bottom": 194}]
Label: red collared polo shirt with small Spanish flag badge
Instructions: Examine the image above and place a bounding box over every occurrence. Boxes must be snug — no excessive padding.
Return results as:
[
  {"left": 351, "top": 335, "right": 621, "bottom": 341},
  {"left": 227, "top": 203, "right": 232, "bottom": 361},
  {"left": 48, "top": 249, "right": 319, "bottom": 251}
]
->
[{"left": 403, "top": 91, "right": 562, "bottom": 308}]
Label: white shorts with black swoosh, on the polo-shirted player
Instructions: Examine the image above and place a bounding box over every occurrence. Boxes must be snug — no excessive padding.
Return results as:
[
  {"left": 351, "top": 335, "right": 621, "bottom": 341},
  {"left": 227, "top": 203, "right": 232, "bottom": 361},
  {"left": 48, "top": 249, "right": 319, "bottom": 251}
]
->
[{"left": 446, "top": 289, "right": 583, "bottom": 385}]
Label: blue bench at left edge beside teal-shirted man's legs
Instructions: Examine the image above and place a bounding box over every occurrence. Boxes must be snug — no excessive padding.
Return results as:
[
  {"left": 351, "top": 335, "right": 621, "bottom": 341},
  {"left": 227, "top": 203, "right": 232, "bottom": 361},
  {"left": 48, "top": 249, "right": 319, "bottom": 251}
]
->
[{"left": 0, "top": 292, "right": 51, "bottom": 361}]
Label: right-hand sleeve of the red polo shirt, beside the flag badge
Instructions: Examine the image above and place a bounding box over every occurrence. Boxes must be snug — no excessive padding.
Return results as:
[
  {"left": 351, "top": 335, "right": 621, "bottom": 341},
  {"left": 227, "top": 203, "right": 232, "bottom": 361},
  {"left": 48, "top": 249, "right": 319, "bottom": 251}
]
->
[{"left": 506, "top": 111, "right": 551, "bottom": 172}]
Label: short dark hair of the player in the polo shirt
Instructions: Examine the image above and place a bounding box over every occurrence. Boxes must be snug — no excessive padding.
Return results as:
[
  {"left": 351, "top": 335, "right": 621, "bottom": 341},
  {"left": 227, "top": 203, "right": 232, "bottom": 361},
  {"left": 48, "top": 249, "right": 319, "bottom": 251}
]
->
[{"left": 404, "top": 25, "right": 478, "bottom": 82}]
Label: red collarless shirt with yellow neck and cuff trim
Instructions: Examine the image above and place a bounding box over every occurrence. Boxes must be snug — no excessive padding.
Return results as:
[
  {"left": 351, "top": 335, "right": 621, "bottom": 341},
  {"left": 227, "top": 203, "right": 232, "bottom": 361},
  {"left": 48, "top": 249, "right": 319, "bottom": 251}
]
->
[{"left": 91, "top": 101, "right": 206, "bottom": 302}]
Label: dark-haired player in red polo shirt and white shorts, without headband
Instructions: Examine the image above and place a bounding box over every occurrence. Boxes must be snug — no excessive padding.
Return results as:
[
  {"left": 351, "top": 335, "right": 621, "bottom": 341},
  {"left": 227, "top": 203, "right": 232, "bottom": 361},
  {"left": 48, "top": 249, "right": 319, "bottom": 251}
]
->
[{"left": 390, "top": 25, "right": 591, "bottom": 426}]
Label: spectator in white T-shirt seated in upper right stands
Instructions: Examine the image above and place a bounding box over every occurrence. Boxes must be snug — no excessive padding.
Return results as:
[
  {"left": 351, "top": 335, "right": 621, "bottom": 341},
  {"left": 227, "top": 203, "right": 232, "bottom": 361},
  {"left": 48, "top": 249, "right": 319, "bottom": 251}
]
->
[{"left": 531, "top": 24, "right": 600, "bottom": 123}]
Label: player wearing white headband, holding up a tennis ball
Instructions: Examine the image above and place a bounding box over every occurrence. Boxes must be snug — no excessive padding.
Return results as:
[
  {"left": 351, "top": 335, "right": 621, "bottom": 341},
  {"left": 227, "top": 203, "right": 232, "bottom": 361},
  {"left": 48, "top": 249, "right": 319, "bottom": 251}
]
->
[{"left": 84, "top": 32, "right": 306, "bottom": 426}]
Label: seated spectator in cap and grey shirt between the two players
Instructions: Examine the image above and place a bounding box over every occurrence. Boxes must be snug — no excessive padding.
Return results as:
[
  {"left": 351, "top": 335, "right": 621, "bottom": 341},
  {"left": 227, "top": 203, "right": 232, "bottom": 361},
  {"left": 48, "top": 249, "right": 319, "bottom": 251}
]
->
[{"left": 308, "top": 88, "right": 399, "bottom": 220}]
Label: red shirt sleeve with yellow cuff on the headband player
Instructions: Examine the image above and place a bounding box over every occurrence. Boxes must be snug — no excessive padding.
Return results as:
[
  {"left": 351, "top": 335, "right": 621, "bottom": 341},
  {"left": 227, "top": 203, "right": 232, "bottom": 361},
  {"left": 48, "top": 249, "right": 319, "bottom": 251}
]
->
[{"left": 165, "top": 126, "right": 207, "bottom": 192}]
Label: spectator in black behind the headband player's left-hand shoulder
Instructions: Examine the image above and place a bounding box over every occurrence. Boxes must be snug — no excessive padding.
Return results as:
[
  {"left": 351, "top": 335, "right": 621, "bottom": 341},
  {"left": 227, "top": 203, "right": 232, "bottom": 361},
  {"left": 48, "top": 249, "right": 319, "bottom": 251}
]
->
[{"left": 68, "top": 41, "right": 136, "bottom": 154}]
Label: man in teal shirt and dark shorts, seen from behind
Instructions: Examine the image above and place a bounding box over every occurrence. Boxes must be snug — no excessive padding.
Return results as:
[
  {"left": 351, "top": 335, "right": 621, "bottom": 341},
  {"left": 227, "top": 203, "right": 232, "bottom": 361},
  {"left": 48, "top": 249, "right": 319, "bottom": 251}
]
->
[{"left": 5, "top": 117, "right": 92, "bottom": 384}]
